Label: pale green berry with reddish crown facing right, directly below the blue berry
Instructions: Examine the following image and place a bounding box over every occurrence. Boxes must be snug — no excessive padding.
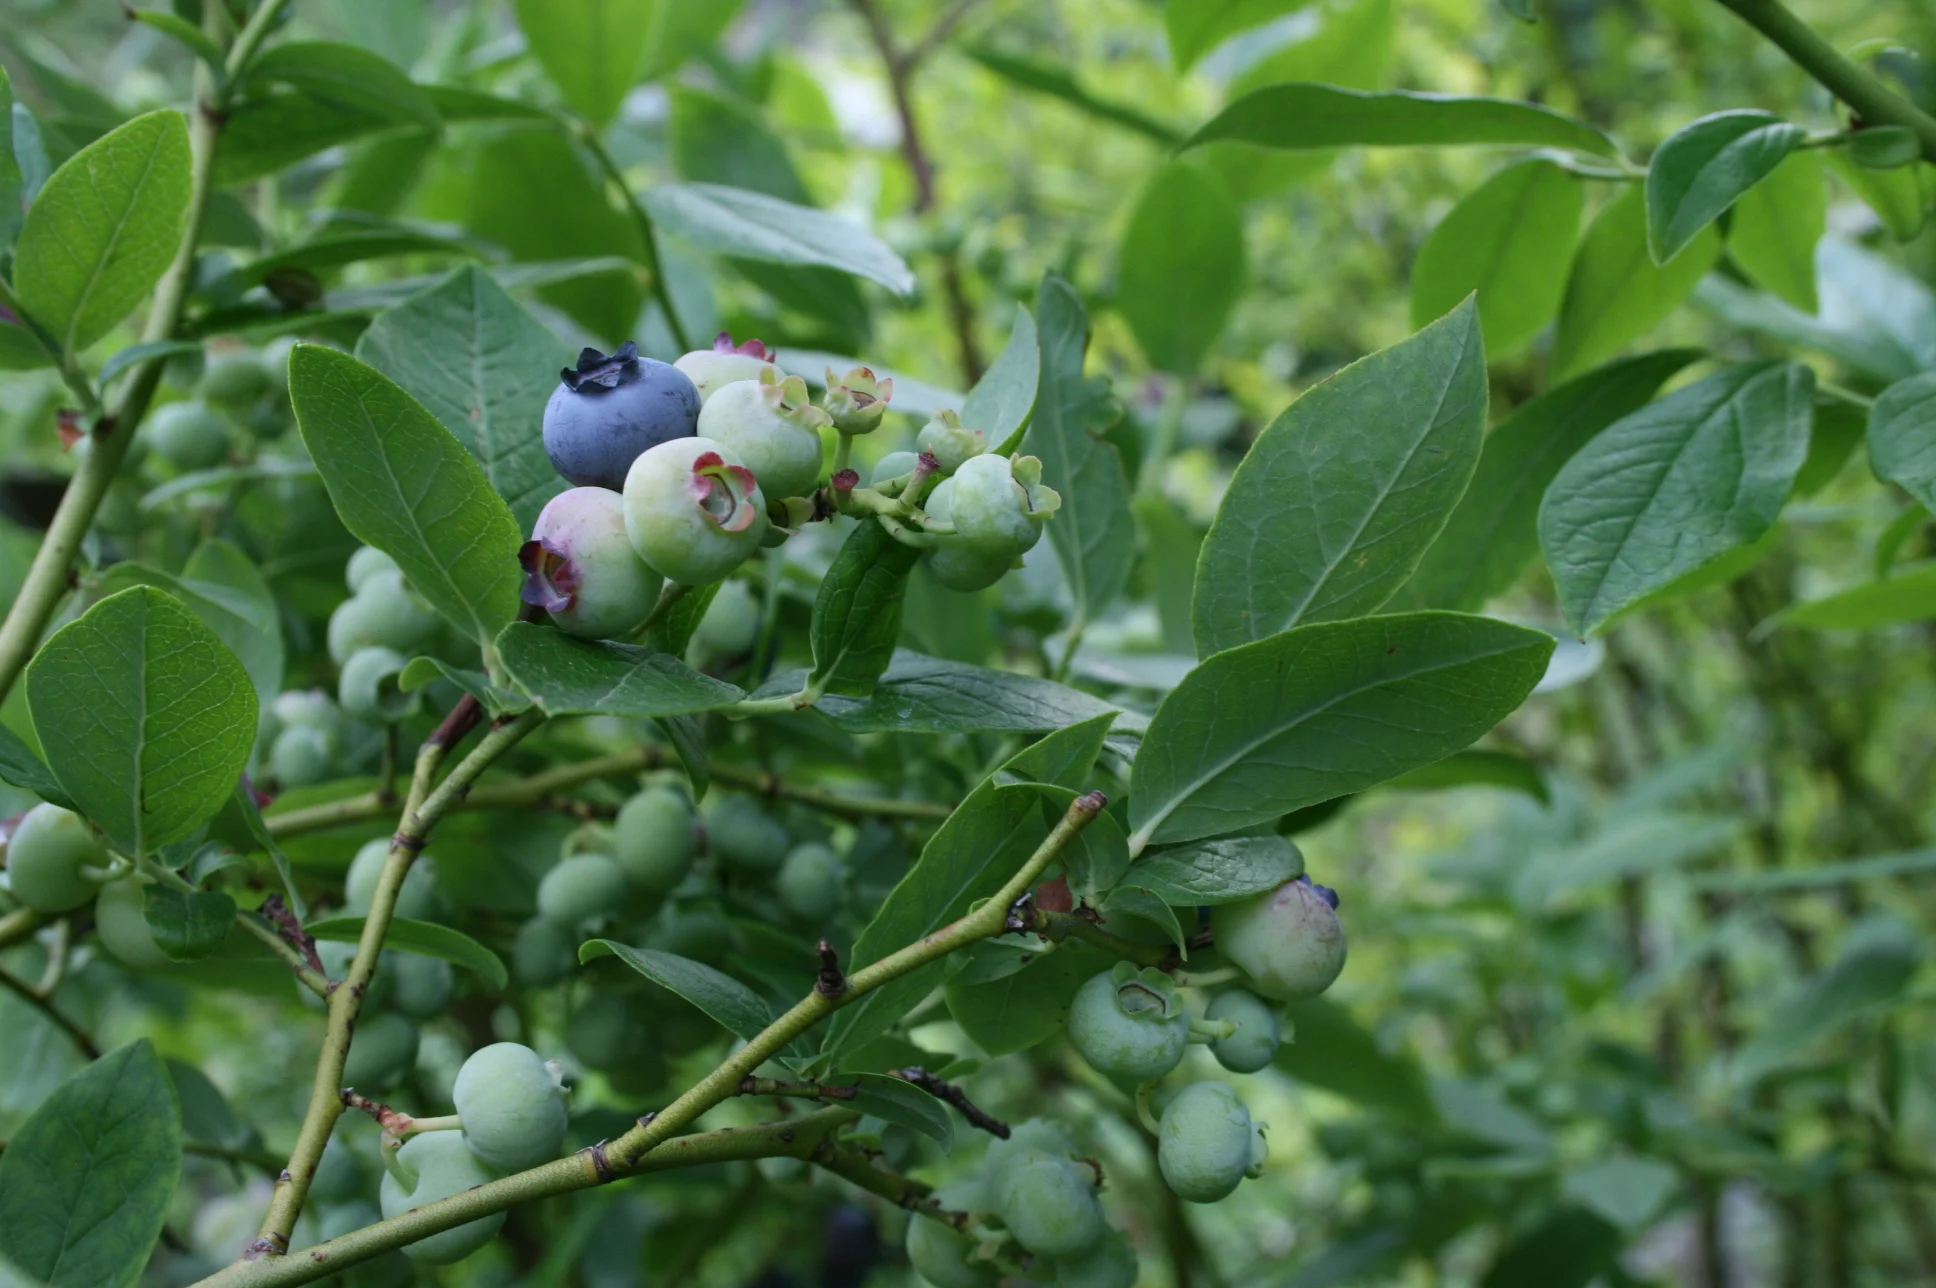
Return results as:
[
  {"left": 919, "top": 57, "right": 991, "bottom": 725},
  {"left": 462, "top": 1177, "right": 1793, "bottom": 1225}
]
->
[{"left": 625, "top": 438, "right": 767, "bottom": 585}]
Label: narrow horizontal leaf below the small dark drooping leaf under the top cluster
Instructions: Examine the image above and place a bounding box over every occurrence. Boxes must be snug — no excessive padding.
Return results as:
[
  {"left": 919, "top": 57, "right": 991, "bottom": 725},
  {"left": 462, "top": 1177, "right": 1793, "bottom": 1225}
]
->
[{"left": 809, "top": 649, "right": 1117, "bottom": 734}]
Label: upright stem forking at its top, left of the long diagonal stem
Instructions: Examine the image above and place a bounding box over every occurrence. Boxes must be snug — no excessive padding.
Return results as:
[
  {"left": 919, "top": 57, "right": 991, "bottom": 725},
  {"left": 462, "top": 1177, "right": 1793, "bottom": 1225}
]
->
[{"left": 248, "top": 711, "right": 544, "bottom": 1259}]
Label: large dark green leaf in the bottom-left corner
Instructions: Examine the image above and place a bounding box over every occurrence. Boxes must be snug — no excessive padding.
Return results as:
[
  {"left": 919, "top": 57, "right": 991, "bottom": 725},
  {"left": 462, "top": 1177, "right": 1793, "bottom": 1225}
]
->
[{"left": 0, "top": 1038, "right": 182, "bottom": 1288}]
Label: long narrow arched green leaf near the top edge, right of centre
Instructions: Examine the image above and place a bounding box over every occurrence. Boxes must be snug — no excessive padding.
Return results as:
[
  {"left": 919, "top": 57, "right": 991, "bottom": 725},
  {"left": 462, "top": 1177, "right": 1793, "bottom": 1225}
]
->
[{"left": 1183, "top": 83, "right": 1618, "bottom": 157}]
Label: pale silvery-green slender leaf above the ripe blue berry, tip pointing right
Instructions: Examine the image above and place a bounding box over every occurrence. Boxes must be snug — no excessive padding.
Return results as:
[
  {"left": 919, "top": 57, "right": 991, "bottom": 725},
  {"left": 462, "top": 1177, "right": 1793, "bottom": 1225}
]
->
[{"left": 641, "top": 184, "right": 914, "bottom": 294}]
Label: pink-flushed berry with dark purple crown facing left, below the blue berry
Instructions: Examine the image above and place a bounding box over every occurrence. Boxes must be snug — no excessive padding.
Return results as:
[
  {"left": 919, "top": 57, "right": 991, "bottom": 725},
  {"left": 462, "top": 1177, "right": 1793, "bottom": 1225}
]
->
[{"left": 517, "top": 488, "right": 664, "bottom": 639}]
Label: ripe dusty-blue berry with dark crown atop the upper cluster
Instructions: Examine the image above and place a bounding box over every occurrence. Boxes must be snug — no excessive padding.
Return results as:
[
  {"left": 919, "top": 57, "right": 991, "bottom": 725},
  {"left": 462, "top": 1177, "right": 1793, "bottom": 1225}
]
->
[{"left": 544, "top": 341, "right": 699, "bottom": 492}]
